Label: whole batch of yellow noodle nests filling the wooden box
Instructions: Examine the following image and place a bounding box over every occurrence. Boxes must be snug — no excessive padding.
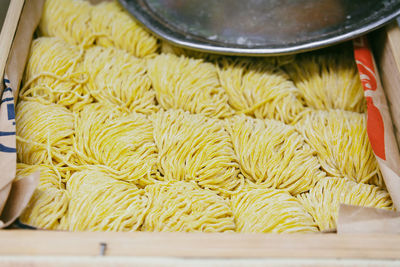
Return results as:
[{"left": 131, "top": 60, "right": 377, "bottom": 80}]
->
[{"left": 16, "top": 0, "right": 393, "bottom": 233}]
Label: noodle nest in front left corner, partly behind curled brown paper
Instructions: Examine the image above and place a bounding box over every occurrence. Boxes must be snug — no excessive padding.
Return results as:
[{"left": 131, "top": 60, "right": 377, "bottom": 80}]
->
[{"left": 16, "top": 164, "right": 69, "bottom": 229}]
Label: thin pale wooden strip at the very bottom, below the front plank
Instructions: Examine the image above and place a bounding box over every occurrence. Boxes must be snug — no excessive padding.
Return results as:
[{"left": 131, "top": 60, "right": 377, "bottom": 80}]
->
[{"left": 0, "top": 256, "right": 400, "bottom": 267}]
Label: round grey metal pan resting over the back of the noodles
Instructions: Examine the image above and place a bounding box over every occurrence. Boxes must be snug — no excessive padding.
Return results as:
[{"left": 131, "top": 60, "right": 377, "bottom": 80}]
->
[{"left": 119, "top": 0, "right": 400, "bottom": 56}]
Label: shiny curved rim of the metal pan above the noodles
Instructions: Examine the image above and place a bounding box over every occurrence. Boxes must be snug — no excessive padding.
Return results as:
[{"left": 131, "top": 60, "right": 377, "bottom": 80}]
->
[{"left": 119, "top": 0, "right": 400, "bottom": 56}]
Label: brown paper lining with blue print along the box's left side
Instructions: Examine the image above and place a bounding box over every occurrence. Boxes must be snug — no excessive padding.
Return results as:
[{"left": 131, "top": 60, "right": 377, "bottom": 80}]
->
[{"left": 0, "top": 0, "right": 44, "bottom": 228}]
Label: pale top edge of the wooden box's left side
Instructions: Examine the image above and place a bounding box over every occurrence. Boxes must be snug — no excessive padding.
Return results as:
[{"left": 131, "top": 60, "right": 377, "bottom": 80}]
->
[{"left": 0, "top": 0, "right": 25, "bottom": 82}]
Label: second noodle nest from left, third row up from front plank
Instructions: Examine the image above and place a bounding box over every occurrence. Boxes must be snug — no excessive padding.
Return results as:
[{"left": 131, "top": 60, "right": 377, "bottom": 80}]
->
[{"left": 83, "top": 47, "right": 157, "bottom": 114}]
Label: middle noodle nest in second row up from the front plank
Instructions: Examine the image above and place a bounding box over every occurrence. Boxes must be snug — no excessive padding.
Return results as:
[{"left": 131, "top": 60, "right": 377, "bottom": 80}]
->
[{"left": 152, "top": 110, "right": 241, "bottom": 193}]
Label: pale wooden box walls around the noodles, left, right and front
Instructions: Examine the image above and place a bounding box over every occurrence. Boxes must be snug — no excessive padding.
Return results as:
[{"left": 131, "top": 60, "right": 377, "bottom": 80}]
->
[{"left": 0, "top": 0, "right": 400, "bottom": 259}]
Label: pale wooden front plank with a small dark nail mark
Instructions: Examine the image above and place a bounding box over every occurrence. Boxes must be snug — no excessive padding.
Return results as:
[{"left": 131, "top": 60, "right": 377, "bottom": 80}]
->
[{"left": 0, "top": 230, "right": 400, "bottom": 259}]
